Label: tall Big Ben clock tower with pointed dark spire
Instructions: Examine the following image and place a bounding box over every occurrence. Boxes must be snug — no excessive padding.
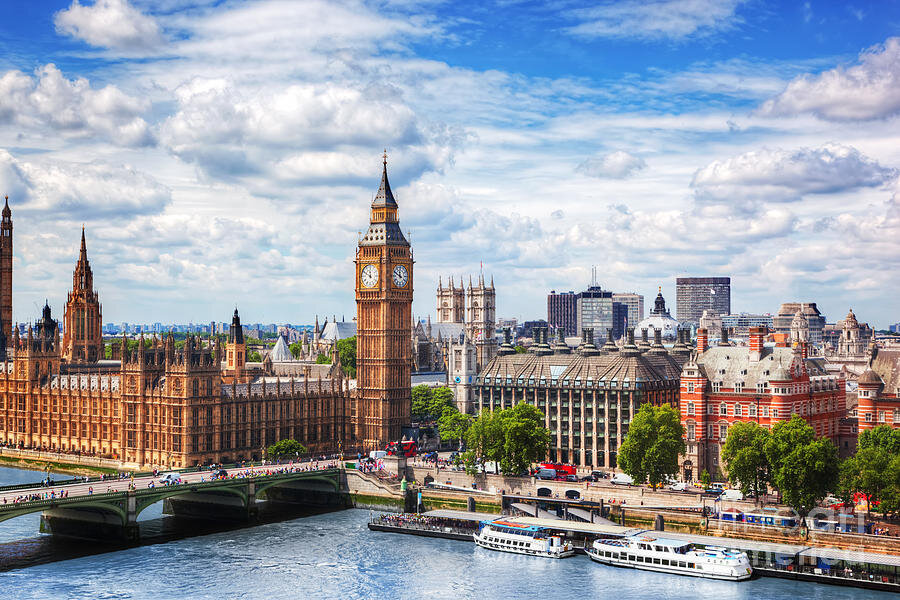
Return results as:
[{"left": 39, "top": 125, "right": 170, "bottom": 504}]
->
[{"left": 355, "top": 152, "right": 413, "bottom": 448}]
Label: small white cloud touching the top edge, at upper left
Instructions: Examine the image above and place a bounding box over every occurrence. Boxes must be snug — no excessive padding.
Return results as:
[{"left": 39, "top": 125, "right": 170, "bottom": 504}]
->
[{"left": 53, "top": 0, "right": 162, "bottom": 50}]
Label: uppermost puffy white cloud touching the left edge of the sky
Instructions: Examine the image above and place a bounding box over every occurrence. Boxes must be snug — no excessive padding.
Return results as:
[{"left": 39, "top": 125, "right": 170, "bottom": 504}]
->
[{"left": 0, "top": 64, "right": 153, "bottom": 146}]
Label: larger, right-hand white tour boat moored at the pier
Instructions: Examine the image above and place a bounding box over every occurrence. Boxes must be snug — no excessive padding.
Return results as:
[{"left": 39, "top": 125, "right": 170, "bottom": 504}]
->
[{"left": 586, "top": 534, "right": 753, "bottom": 581}]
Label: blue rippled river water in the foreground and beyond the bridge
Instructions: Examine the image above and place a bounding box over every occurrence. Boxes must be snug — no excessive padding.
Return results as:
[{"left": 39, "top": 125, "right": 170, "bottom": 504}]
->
[{"left": 0, "top": 468, "right": 896, "bottom": 600}]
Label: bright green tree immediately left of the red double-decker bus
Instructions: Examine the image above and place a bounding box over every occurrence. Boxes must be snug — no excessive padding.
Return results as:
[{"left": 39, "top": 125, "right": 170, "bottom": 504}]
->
[{"left": 495, "top": 402, "right": 550, "bottom": 475}]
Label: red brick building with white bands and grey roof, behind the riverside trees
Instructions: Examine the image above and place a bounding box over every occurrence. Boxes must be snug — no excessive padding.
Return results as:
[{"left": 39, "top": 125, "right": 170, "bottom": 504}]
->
[{"left": 680, "top": 327, "right": 846, "bottom": 480}]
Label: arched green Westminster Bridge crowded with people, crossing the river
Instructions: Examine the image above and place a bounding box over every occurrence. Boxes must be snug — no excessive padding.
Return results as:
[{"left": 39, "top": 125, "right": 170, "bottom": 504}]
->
[{"left": 0, "top": 461, "right": 356, "bottom": 543}]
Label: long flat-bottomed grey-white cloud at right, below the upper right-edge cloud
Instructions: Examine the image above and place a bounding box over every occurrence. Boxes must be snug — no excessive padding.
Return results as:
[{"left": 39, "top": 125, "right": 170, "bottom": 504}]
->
[{"left": 691, "top": 144, "right": 897, "bottom": 203}]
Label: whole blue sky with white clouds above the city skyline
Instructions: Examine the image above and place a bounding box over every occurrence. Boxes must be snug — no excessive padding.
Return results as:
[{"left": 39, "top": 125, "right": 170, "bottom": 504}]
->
[{"left": 0, "top": 0, "right": 900, "bottom": 326}]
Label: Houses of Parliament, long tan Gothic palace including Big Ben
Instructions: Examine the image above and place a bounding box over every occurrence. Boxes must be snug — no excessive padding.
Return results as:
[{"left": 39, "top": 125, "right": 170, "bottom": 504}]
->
[{"left": 0, "top": 157, "right": 413, "bottom": 467}]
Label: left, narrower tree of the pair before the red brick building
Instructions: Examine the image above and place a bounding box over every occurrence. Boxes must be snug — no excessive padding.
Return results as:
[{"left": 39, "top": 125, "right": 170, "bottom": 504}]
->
[{"left": 722, "top": 421, "right": 770, "bottom": 498}]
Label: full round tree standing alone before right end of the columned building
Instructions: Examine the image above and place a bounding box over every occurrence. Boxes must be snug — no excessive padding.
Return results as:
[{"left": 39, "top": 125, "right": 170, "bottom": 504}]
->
[{"left": 617, "top": 403, "right": 686, "bottom": 486}]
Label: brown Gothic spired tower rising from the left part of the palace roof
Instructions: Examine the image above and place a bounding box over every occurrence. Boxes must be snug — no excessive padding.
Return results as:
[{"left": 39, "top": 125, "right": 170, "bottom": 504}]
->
[{"left": 63, "top": 228, "right": 103, "bottom": 363}]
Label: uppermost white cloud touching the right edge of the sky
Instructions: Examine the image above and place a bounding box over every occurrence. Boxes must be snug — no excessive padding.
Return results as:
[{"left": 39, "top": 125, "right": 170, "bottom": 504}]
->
[{"left": 758, "top": 38, "right": 900, "bottom": 121}]
